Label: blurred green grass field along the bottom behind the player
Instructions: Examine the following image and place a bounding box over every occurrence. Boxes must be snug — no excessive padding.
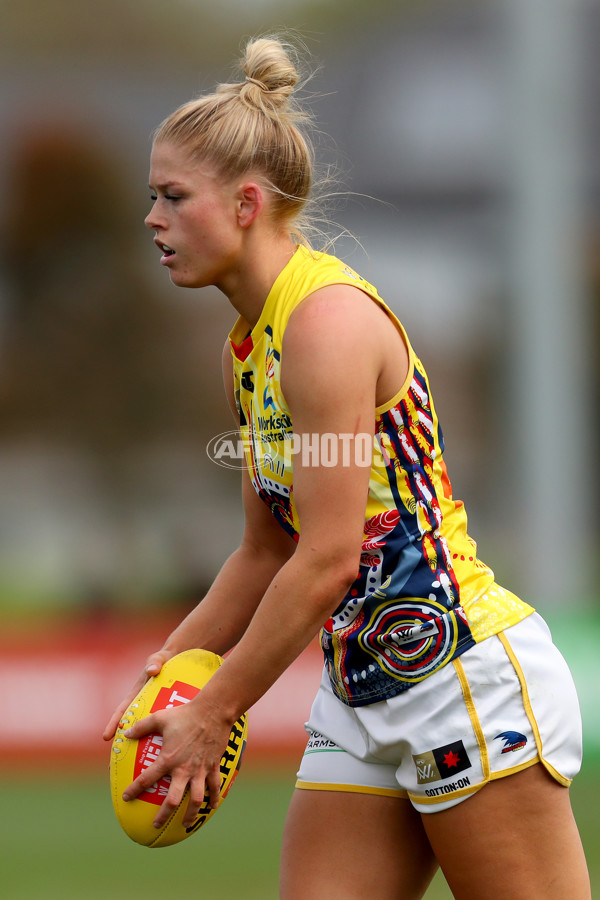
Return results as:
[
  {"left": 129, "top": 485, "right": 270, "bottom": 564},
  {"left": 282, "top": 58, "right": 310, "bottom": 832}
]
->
[{"left": 0, "top": 761, "right": 600, "bottom": 900}]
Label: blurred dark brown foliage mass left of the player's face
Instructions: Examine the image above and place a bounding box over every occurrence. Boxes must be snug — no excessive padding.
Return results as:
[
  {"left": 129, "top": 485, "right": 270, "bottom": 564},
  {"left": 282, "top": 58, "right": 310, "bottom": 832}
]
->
[{"left": 0, "top": 123, "right": 231, "bottom": 455}]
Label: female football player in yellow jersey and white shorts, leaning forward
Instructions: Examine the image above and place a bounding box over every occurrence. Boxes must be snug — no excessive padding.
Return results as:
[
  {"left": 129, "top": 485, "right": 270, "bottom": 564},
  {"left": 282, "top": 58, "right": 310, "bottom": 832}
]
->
[{"left": 105, "top": 39, "right": 590, "bottom": 900}]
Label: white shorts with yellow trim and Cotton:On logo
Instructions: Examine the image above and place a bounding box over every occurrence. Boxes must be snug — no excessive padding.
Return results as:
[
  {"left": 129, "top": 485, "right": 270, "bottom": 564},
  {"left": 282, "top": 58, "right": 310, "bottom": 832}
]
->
[{"left": 296, "top": 613, "right": 582, "bottom": 813}]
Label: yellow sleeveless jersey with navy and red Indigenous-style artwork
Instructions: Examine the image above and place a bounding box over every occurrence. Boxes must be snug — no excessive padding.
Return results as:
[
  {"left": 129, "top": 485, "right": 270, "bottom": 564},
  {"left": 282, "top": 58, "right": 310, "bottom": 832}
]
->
[{"left": 229, "top": 247, "right": 533, "bottom": 706}]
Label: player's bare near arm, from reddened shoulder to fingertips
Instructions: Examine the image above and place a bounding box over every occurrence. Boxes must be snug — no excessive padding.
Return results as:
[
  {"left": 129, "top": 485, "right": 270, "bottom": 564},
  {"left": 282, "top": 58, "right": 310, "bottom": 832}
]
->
[{"left": 118, "top": 289, "right": 398, "bottom": 823}]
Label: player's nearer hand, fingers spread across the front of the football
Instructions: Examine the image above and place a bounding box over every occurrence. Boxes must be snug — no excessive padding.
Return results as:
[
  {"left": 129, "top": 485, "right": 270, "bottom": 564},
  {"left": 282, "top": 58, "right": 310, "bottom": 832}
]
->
[{"left": 123, "top": 695, "right": 233, "bottom": 828}]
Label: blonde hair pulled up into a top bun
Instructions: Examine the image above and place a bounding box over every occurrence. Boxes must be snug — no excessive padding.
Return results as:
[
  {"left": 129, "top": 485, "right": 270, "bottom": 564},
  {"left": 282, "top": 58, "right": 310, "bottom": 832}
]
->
[{"left": 154, "top": 37, "right": 314, "bottom": 241}]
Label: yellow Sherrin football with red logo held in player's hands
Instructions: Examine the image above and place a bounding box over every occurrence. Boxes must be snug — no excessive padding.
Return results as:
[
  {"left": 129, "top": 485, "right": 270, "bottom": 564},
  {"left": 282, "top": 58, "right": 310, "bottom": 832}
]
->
[{"left": 110, "top": 650, "right": 248, "bottom": 847}]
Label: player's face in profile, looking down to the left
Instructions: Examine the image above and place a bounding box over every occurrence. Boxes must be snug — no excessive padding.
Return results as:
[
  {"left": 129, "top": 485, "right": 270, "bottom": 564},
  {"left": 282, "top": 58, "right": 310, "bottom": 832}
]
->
[{"left": 146, "top": 142, "right": 240, "bottom": 293}]
